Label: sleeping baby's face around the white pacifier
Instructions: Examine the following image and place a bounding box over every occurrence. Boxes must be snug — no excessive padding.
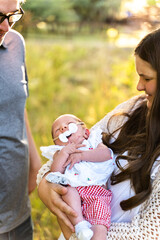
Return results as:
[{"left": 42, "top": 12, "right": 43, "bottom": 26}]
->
[{"left": 52, "top": 115, "right": 85, "bottom": 146}]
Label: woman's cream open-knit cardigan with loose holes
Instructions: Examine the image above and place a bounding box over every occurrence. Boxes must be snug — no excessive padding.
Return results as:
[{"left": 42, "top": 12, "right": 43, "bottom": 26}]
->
[{"left": 37, "top": 96, "right": 160, "bottom": 240}]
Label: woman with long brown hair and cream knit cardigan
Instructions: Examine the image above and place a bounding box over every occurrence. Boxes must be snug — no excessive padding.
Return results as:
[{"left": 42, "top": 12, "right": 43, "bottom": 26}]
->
[{"left": 39, "top": 29, "right": 160, "bottom": 240}]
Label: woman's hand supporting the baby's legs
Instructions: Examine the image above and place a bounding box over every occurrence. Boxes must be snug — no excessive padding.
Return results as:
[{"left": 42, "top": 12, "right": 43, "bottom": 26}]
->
[{"left": 38, "top": 177, "right": 77, "bottom": 232}]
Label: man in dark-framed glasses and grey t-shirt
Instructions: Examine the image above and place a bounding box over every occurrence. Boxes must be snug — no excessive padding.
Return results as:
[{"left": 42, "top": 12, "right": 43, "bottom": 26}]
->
[{"left": 0, "top": 0, "right": 41, "bottom": 240}]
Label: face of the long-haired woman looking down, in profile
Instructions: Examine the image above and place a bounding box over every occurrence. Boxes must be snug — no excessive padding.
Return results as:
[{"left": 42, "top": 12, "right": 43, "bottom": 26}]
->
[{"left": 135, "top": 55, "right": 157, "bottom": 109}]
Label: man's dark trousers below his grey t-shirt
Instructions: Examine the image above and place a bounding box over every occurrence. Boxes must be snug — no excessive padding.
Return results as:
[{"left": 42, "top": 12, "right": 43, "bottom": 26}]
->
[{"left": 0, "top": 217, "right": 33, "bottom": 240}]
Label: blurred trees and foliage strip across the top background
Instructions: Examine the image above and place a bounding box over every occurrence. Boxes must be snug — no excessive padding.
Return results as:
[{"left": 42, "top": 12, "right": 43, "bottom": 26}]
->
[{"left": 15, "top": 0, "right": 160, "bottom": 37}]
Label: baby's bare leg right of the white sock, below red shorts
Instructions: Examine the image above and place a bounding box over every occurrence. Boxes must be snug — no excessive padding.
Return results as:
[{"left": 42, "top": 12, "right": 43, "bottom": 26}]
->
[{"left": 91, "top": 225, "right": 107, "bottom": 240}]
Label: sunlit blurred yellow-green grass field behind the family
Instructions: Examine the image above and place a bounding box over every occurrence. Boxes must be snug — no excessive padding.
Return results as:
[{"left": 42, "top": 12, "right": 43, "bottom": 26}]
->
[{"left": 26, "top": 34, "right": 137, "bottom": 240}]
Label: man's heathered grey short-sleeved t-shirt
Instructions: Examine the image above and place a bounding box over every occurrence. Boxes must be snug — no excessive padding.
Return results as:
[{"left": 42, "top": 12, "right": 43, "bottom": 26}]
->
[{"left": 0, "top": 30, "right": 30, "bottom": 233}]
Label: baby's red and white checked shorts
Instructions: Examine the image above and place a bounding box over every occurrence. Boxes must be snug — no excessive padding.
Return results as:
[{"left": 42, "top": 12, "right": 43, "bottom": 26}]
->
[{"left": 76, "top": 186, "right": 112, "bottom": 229}]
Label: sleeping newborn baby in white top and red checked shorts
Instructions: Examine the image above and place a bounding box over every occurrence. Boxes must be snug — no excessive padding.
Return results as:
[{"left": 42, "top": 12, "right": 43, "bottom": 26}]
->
[{"left": 40, "top": 114, "right": 114, "bottom": 240}]
